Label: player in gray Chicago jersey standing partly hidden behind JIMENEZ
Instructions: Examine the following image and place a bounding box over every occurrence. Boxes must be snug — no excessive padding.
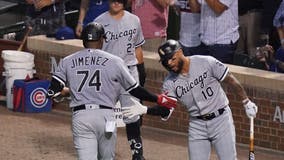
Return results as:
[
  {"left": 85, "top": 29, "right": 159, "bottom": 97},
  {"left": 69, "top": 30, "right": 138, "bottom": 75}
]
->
[{"left": 94, "top": 0, "right": 173, "bottom": 160}]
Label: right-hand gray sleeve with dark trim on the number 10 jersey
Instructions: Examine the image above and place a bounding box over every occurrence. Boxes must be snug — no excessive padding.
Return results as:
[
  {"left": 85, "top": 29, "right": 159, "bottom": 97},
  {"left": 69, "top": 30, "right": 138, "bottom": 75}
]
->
[{"left": 208, "top": 56, "right": 229, "bottom": 81}]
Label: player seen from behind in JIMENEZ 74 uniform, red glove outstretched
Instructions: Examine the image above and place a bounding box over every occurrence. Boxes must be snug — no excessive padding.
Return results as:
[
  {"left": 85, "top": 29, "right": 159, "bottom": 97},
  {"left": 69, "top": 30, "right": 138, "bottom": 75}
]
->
[{"left": 48, "top": 23, "right": 176, "bottom": 160}]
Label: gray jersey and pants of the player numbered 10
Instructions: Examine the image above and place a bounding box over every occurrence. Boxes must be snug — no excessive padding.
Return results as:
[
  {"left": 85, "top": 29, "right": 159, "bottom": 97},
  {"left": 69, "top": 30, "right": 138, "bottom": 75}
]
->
[{"left": 163, "top": 55, "right": 237, "bottom": 160}]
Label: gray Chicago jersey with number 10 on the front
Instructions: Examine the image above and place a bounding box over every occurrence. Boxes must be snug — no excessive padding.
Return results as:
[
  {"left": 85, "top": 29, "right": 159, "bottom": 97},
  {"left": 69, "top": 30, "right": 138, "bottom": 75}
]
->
[{"left": 163, "top": 55, "right": 229, "bottom": 116}]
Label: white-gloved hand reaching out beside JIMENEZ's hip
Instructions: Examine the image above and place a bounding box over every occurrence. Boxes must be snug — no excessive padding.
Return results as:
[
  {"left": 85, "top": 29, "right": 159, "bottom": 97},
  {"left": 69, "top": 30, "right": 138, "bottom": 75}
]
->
[{"left": 122, "top": 98, "right": 148, "bottom": 118}]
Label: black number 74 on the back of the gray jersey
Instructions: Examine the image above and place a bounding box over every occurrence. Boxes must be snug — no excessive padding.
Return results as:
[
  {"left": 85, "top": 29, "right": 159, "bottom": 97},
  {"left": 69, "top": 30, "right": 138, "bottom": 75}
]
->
[{"left": 77, "top": 70, "right": 102, "bottom": 92}]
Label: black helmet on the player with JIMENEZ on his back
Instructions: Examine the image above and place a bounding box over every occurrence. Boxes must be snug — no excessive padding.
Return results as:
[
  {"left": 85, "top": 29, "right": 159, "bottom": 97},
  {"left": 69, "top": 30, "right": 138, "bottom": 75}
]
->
[{"left": 81, "top": 22, "right": 105, "bottom": 41}]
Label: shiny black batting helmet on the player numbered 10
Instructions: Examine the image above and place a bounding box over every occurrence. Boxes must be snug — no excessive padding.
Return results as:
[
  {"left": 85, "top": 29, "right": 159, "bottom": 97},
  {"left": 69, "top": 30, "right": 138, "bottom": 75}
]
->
[{"left": 158, "top": 39, "right": 181, "bottom": 70}]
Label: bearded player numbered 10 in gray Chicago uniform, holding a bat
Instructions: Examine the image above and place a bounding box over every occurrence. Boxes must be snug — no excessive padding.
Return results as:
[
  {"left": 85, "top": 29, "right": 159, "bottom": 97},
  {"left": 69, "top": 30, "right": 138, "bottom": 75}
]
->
[{"left": 123, "top": 40, "right": 258, "bottom": 160}]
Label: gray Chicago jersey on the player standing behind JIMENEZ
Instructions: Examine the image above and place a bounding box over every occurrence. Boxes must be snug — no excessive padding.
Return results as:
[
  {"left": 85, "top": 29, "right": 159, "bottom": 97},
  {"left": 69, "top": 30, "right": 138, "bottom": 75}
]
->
[{"left": 94, "top": 11, "right": 145, "bottom": 66}]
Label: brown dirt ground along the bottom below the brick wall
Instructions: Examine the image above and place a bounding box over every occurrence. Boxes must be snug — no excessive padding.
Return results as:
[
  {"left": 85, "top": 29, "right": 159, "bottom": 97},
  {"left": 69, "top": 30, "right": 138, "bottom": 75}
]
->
[{"left": 0, "top": 106, "right": 284, "bottom": 160}]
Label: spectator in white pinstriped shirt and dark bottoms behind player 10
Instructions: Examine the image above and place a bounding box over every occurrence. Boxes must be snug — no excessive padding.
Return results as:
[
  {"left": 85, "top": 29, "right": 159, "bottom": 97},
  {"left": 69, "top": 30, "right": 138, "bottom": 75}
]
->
[{"left": 189, "top": 0, "right": 239, "bottom": 64}]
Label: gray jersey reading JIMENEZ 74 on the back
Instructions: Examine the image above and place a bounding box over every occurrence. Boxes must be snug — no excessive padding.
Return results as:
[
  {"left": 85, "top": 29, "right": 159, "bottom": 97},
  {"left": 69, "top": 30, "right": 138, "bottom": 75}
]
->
[{"left": 53, "top": 49, "right": 138, "bottom": 107}]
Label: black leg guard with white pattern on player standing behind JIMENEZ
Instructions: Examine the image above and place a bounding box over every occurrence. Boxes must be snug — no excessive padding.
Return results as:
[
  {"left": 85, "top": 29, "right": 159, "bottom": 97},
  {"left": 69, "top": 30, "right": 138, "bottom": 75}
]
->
[{"left": 126, "top": 119, "right": 144, "bottom": 160}]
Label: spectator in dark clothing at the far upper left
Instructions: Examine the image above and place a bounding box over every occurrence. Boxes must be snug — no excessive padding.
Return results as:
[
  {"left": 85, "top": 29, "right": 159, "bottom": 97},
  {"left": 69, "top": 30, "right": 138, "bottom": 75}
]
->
[{"left": 25, "top": 0, "right": 65, "bottom": 37}]
